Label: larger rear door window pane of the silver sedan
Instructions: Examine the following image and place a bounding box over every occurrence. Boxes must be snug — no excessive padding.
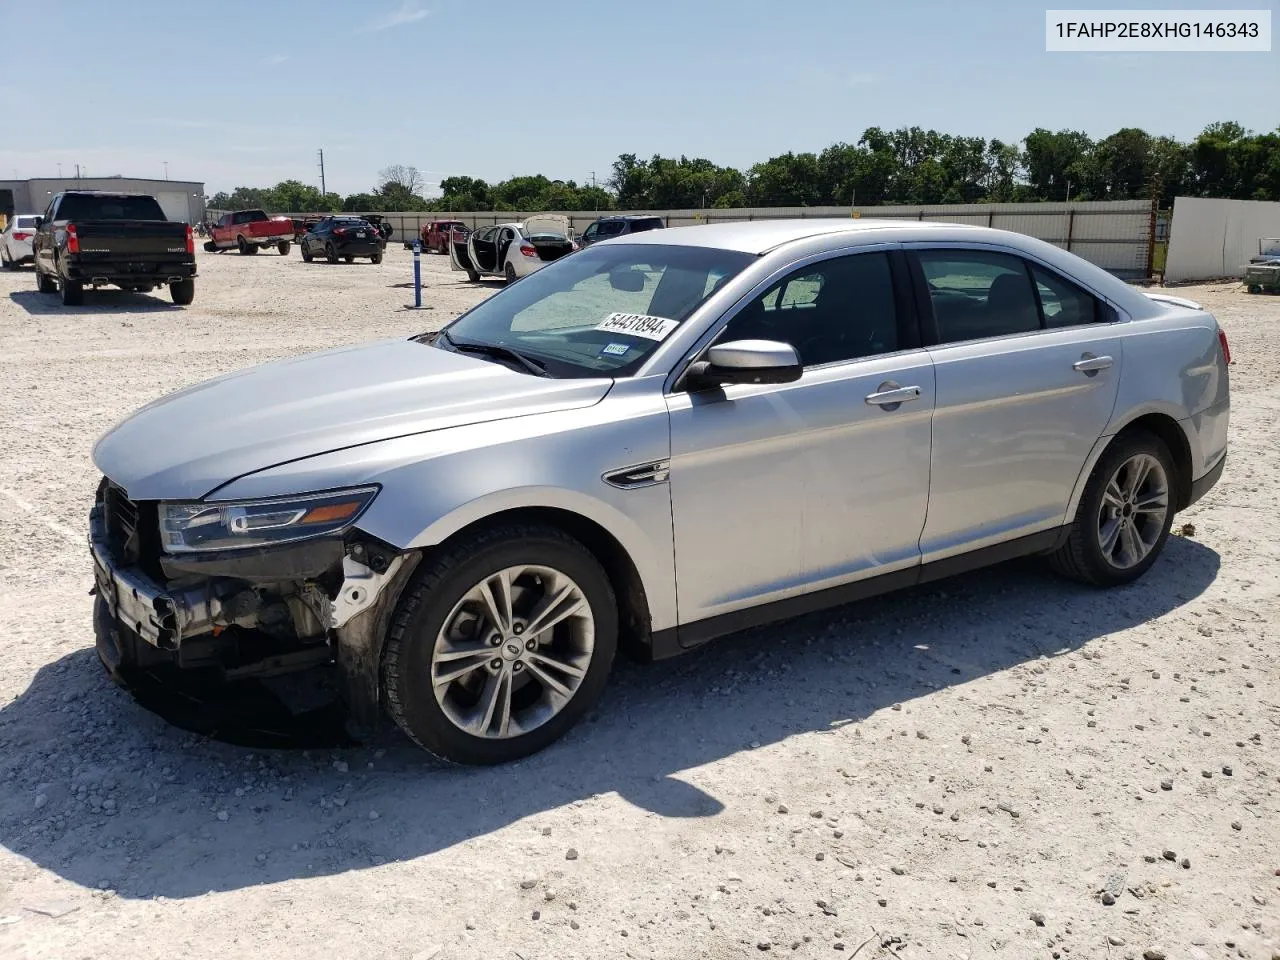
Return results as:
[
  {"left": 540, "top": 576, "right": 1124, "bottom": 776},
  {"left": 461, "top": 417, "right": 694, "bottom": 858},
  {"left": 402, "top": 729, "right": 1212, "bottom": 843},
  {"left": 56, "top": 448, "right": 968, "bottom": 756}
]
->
[{"left": 916, "top": 250, "right": 1041, "bottom": 343}]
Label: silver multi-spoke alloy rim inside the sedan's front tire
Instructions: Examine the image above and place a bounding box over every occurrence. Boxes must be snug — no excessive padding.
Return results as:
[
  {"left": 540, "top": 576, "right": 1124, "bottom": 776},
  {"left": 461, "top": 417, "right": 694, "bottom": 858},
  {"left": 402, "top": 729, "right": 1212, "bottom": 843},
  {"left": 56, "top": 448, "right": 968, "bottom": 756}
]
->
[{"left": 431, "top": 564, "right": 595, "bottom": 740}]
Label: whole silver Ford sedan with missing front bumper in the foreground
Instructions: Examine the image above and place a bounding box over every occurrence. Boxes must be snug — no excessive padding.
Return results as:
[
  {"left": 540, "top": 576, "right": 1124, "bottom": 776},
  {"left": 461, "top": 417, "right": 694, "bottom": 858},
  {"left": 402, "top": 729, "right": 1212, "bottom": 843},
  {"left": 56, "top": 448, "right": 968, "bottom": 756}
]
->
[{"left": 90, "top": 220, "right": 1229, "bottom": 763}]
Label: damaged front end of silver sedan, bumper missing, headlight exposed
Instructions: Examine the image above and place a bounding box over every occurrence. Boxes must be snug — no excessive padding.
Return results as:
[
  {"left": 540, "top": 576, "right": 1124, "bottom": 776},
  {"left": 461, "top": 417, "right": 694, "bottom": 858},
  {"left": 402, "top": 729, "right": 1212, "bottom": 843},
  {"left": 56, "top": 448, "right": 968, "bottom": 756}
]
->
[{"left": 90, "top": 479, "right": 420, "bottom": 728}]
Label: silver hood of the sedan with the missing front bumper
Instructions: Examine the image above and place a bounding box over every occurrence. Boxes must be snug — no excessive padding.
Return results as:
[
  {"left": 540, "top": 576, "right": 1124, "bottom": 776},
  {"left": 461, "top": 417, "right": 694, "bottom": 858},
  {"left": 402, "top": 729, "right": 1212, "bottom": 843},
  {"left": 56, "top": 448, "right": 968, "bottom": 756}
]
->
[{"left": 93, "top": 339, "right": 613, "bottom": 500}]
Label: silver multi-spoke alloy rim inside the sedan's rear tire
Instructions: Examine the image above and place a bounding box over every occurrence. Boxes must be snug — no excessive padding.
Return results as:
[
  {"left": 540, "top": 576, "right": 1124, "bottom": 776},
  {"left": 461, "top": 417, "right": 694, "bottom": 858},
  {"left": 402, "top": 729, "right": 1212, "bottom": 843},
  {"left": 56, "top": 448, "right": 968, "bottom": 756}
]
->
[{"left": 1097, "top": 453, "right": 1169, "bottom": 570}]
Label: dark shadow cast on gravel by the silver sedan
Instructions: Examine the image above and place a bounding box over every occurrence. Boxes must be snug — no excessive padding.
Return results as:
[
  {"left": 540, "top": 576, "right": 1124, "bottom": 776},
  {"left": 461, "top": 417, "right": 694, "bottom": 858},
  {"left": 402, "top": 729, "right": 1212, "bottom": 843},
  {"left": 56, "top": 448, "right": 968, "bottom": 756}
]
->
[{"left": 0, "top": 538, "right": 1220, "bottom": 897}]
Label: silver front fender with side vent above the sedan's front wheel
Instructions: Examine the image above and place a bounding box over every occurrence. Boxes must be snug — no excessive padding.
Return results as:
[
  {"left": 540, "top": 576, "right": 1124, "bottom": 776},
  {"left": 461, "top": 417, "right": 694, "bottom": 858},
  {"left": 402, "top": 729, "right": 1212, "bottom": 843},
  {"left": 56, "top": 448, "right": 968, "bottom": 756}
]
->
[{"left": 207, "top": 378, "right": 676, "bottom": 630}]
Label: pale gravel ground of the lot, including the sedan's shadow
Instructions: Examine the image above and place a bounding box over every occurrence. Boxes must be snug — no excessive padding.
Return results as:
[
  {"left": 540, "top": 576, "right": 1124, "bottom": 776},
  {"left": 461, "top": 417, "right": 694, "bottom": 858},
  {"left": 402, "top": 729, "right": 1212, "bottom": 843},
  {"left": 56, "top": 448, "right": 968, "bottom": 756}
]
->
[{"left": 0, "top": 247, "right": 1280, "bottom": 960}]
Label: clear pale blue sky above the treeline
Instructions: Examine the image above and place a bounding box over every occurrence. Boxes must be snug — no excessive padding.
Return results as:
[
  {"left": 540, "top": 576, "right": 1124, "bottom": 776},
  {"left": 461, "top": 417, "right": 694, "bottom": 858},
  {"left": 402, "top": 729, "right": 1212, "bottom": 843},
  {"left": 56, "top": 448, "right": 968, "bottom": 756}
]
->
[{"left": 0, "top": 0, "right": 1280, "bottom": 193}]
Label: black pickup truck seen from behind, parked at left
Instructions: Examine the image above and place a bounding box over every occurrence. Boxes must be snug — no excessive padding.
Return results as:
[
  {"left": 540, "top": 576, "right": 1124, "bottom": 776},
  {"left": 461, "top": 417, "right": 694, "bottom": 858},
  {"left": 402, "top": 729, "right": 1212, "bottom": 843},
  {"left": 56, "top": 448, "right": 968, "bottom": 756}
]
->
[{"left": 33, "top": 191, "right": 196, "bottom": 306}]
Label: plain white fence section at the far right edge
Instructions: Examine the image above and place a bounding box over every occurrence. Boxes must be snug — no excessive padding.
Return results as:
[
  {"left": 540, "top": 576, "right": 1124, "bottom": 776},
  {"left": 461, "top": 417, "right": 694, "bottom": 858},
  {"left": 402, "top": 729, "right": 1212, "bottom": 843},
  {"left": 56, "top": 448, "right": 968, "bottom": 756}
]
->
[{"left": 1165, "top": 197, "right": 1280, "bottom": 283}]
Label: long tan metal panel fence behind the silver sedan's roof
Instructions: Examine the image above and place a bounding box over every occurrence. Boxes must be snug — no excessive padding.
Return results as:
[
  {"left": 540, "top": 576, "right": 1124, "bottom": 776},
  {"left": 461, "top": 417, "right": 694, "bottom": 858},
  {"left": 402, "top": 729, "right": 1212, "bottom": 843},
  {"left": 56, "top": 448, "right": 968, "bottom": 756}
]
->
[{"left": 249, "top": 200, "right": 1156, "bottom": 279}]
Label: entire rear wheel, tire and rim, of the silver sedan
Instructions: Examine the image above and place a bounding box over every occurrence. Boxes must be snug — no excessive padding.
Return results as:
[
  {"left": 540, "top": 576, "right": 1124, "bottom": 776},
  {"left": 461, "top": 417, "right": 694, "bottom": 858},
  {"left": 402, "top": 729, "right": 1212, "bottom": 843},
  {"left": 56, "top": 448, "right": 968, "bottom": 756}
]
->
[{"left": 1050, "top": 430, "right": 1178, "bottom": 586}]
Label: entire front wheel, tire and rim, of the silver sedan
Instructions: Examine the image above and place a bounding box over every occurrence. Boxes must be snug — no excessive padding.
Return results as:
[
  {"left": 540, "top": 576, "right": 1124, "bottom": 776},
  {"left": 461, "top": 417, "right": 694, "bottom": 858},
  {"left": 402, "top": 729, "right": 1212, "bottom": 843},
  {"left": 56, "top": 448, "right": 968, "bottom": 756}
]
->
[{"left": 381, "top": 524, "right": 618, "bottom": 764}]
